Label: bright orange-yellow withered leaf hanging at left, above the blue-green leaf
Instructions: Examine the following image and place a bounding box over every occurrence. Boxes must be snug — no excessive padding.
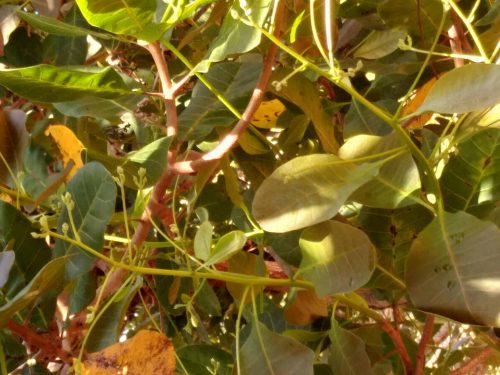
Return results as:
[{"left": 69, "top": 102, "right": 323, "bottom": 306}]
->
[{"left": 45, "top": 125, "right": 85, "bottom": 180}]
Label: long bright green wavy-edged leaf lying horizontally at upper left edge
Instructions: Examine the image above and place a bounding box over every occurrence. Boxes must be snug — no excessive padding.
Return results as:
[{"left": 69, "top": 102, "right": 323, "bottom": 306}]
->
[{"left": 0, "top": 65, "right": 136, "bottom": 103}]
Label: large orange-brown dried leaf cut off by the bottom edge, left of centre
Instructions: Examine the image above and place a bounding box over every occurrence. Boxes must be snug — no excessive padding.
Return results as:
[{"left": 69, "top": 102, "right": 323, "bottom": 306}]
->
[{"left": 81, "top": 330, "right": 175, "bottom": 375}]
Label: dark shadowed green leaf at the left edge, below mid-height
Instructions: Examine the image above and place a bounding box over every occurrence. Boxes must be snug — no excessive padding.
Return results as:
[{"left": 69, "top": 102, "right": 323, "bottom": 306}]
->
[{"left": 0, "top": 201, "right": 52, "bottom": 285}]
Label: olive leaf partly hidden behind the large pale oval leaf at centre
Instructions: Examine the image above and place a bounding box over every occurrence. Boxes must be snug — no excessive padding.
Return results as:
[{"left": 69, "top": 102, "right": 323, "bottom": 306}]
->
[{"left": 339, "top": 133, "right": 421, "bottom": 208}]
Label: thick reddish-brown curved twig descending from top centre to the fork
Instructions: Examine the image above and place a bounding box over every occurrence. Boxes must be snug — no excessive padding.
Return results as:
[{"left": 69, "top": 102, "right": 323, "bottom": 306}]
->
[{"left": 171, "top": 1, "right": 285, "bottom": 174}]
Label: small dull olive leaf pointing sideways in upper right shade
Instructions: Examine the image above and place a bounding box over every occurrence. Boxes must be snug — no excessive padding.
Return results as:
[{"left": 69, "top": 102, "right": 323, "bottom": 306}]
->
[{"left": 354, "top": 30, "right": 406, "bottom": 60}]
